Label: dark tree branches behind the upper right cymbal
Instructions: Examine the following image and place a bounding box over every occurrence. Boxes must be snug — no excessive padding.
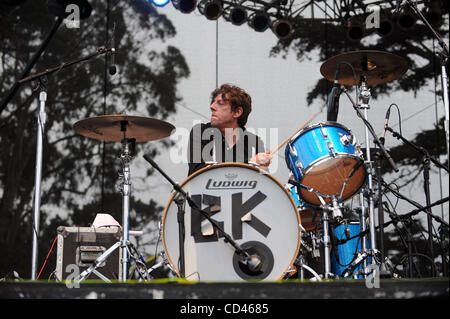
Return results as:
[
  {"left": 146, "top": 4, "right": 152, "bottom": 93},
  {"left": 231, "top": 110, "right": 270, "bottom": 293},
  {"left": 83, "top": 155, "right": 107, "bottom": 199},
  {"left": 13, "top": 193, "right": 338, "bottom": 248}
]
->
[{"left": 271, "top": 1, "right": 448, "bottom": 104}]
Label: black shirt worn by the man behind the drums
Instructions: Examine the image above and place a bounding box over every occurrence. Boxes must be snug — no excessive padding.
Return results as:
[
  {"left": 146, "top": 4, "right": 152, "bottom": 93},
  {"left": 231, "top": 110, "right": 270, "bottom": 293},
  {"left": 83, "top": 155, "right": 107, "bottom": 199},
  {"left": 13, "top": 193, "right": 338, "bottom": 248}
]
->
[{"left": 188, "top": 123, "right": 264, "bottom": 175}]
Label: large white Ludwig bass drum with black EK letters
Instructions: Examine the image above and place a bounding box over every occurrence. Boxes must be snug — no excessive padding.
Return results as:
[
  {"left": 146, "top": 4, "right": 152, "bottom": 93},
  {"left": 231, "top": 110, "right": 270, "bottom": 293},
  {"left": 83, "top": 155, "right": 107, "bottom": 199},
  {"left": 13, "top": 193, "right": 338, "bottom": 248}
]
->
[{"left": 161, "top": 163, "right": 301, "bottom": 281}]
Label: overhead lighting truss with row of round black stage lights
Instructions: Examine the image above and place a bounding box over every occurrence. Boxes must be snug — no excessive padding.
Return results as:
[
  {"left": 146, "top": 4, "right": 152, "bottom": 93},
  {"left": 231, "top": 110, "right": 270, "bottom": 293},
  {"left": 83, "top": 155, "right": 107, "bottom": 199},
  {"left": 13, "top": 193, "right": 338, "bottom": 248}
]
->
[{"left": 170, "top": 0, "right": 440, "bottom": 41}]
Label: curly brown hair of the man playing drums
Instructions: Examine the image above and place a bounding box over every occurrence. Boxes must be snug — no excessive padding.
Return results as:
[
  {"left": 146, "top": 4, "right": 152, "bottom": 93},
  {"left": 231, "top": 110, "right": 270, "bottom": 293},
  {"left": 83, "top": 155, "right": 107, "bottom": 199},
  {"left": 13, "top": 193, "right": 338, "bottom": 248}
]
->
[{"left": 211, "top": 84, "right": 252, "bottom": 127}]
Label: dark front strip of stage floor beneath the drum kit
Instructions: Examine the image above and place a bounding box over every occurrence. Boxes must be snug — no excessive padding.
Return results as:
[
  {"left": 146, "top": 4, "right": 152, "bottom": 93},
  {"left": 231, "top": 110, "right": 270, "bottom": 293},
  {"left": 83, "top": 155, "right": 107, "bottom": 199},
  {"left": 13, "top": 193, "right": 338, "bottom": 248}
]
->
[{"left": 0, "top": 277, "right": 449, "bottom": 300}]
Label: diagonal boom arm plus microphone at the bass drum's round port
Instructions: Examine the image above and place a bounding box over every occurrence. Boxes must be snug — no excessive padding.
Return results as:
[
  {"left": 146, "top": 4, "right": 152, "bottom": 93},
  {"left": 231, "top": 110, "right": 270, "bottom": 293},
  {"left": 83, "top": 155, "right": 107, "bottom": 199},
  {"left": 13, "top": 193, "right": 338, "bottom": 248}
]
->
[{"left": 143, "top": 155, "right": 261, "bottom": 271}]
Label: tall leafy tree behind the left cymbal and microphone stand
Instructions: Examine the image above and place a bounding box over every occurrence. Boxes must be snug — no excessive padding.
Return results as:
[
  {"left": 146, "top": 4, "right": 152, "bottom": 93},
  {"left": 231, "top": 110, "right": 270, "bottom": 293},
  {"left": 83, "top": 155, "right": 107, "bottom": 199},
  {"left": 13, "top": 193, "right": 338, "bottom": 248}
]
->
[{"left": 0, "top": 0, "right": 189, "bottom": 277}]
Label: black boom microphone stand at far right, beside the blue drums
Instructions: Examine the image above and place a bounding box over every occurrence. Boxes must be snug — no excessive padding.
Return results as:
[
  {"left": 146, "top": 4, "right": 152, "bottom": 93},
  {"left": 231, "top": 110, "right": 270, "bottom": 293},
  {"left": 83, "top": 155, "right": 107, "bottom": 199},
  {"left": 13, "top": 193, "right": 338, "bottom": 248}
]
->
[{"left": 386, "top": 126, "right": 448, "bottom": 275}]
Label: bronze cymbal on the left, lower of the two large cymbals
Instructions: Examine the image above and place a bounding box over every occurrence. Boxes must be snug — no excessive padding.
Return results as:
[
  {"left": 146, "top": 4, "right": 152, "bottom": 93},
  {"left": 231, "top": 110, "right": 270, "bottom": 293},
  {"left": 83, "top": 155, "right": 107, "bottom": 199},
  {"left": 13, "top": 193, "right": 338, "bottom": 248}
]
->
[{"left": 73, "top": 114, "right": 175, "bottom": 142}]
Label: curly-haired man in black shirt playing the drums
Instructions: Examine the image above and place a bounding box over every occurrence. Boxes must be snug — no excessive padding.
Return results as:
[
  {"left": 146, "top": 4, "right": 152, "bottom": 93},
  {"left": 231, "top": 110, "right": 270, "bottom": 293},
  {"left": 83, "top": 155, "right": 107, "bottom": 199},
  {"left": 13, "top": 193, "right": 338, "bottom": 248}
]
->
[{"left": 188, "top": 84, "right": 272, "bottom": 175}]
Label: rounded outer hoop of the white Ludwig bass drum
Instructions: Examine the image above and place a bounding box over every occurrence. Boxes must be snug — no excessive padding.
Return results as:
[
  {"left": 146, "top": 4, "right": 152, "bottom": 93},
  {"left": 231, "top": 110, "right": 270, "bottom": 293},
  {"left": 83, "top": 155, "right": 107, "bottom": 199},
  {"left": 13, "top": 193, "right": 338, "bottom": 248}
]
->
[{"left": 160, "top": 162, "right": 302, "bottom": 280}]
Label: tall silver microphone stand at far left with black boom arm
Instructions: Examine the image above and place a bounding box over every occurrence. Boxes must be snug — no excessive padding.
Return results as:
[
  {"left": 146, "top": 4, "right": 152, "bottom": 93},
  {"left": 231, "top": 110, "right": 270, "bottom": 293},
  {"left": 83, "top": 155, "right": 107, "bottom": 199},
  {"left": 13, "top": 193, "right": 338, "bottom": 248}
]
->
[{"left": 18, "top": 46, "right": 114, "bottom": 280}]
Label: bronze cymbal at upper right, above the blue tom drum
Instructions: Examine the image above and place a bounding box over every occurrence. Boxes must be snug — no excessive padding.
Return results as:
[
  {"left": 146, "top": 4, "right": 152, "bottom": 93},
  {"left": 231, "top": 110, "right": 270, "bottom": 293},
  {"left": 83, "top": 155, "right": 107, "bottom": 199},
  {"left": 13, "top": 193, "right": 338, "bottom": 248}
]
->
[{"left": 320, "top": 50, "right": 408, "bottom": 86}]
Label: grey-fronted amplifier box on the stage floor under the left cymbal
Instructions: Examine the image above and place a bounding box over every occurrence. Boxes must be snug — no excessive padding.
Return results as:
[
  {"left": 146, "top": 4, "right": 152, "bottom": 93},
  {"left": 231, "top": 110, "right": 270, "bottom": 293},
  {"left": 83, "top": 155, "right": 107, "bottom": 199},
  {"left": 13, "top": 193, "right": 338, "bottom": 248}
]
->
[{"left": 56, "top": 226, "right": 122, "bottom": 281}]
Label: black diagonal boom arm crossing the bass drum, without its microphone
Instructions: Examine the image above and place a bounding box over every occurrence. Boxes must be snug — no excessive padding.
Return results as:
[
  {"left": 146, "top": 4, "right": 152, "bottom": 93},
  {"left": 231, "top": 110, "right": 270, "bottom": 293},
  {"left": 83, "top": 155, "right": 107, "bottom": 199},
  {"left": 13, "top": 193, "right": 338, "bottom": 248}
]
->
[{"left": 144, "top": 155, "right": 250, "bottom": 276}]
